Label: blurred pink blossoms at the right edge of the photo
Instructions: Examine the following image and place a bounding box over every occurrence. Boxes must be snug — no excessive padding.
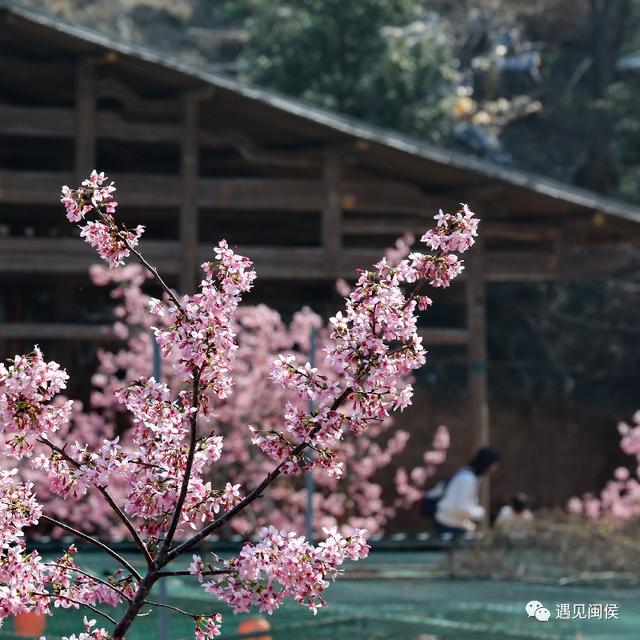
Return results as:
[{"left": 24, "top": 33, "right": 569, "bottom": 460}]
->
[{"left": 567, "top": 411, "right": 640, "bottom": 526}]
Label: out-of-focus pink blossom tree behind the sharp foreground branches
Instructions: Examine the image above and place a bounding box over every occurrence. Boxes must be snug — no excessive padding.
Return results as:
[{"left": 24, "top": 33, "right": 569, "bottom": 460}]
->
[{"left": 47, "top": 262, "right": 448, "bottom": 536}]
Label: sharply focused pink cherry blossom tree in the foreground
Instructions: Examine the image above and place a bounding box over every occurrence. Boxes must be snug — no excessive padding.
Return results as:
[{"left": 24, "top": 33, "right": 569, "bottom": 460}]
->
[{"left": 0, "top": 171, "right": 477, "bottom": 640}]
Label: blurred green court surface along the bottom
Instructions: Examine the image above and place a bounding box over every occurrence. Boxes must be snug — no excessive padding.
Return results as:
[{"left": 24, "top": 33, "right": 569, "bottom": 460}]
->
[{"left": 0, "top": 552, "right": 640, "bottom": 640}]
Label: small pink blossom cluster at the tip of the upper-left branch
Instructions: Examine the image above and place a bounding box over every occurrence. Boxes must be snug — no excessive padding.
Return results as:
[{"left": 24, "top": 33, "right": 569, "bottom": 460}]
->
[{"left": 60, "top": 170, "right": 144, "bottom": 267}]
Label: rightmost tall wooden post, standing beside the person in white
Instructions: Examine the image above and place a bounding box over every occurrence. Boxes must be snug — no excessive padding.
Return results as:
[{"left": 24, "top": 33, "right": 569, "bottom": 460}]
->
[{"left": 465, "top": 236, "right": 490, "bottom": 524}]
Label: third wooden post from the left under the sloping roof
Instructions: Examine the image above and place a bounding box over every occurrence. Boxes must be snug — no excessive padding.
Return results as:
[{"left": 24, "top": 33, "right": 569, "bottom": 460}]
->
[{"left": 322, "top": 151, "right": 342, "bottom": 276}]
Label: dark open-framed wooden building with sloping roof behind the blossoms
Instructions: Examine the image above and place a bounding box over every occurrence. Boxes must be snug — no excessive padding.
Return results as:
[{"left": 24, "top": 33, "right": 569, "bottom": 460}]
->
[{"left": 0, "top": 5, "right": 640, "bottom": 500}]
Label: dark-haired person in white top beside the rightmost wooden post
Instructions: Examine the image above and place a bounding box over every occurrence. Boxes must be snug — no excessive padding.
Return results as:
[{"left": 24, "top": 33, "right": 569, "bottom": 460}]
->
[{"left": 435, "top": 447, "right": 500, "bottom": 537}]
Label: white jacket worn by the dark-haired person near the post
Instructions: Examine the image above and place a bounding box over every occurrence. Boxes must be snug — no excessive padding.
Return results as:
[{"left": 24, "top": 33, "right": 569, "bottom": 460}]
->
[{"left": 436, "top": 468, "right": 484, "bottom": 531}]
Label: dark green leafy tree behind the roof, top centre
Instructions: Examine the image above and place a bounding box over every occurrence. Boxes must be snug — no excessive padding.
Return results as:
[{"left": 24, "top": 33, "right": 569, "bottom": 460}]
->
[{"left": 243, "top": 0, "right": 457, "bottom": 140}]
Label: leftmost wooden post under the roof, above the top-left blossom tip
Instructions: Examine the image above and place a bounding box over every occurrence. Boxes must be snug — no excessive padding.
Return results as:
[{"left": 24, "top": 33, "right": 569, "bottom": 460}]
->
[{"left": 74, "top": 60, "right": 97, "bottom": 180}]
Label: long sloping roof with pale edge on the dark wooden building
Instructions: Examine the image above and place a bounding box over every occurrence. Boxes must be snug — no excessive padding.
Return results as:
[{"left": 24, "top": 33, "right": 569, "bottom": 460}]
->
[{"left": 0, "top": 0, "right": 640, "bottom": 235}]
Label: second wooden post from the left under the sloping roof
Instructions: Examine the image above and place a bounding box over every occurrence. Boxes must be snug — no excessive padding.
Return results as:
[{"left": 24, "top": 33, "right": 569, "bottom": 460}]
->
[{"left": 180, "top": 95, "right": 199, "bottom": 294}]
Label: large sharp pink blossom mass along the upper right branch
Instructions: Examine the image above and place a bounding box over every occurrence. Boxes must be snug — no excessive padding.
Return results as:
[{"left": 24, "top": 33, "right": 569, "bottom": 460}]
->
[{"left": 253, "top": 205, "right": 478, "bottom": 475}]
